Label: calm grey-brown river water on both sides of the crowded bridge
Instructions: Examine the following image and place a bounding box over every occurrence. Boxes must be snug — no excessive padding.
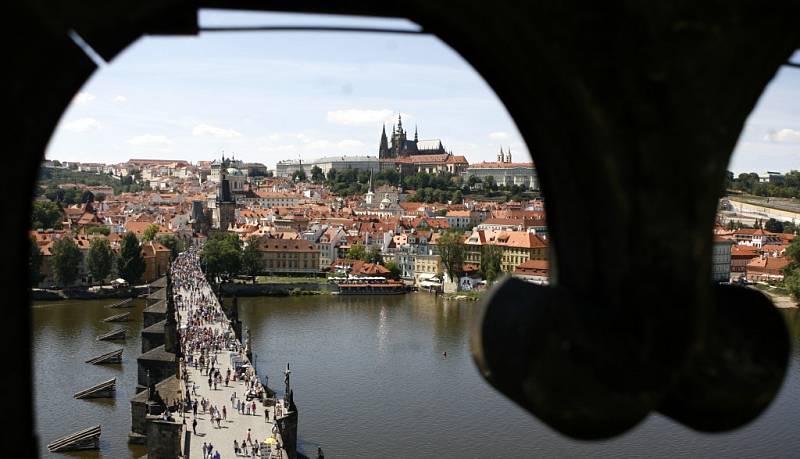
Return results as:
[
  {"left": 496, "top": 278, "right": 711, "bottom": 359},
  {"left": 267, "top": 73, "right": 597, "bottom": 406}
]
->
[{"left": 33, "top": 293, "right": 800, "bottom": 458}]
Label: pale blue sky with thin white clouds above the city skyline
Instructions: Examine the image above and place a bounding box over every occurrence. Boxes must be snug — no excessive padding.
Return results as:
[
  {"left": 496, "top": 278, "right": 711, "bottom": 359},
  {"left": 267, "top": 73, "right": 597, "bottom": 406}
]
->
[{"left": 46, "top": 11, "right": 800, "bottom": 173}]
